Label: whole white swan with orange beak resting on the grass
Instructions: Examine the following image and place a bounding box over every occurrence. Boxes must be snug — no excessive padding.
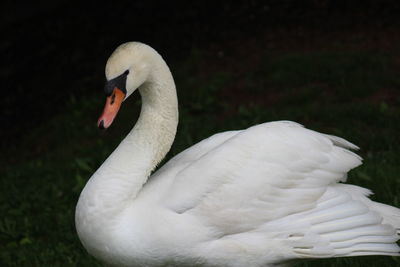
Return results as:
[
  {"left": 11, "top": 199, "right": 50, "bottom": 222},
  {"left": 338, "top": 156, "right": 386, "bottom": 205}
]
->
[{"left": 76, "top": 42, "right": 400, "bottom": 266}]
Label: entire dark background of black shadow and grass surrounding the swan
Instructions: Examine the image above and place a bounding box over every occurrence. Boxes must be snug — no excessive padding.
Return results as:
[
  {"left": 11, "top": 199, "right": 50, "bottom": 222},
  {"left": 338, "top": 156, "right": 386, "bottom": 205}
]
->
[{"left": 0, "top": 0, "right": 400, "bottom": 267}]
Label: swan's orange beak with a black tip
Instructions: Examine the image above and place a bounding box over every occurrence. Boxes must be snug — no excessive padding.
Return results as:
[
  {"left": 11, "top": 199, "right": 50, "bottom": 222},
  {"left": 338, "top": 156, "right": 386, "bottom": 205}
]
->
[{"left": 97, "top": 87, "right": 125, "bottom": 129}]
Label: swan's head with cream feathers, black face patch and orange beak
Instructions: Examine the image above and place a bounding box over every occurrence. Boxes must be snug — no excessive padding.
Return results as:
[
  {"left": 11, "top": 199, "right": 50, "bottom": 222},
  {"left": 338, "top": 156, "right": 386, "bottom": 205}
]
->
[{"left": 97, "top": 42, "right": 157, "bottom": 129}]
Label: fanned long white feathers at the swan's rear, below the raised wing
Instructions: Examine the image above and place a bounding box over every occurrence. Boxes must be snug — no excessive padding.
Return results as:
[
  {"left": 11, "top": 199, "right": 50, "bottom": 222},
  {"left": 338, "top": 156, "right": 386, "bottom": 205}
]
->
[{"left": 282, "top": 184, "right": 400, "bottom": 258}]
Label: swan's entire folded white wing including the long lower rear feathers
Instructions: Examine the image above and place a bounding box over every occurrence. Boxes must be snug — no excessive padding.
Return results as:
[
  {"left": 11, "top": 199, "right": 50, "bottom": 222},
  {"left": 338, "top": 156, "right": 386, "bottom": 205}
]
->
[{"left": 148, "top": 121, "right": 400, "bottom": 266}]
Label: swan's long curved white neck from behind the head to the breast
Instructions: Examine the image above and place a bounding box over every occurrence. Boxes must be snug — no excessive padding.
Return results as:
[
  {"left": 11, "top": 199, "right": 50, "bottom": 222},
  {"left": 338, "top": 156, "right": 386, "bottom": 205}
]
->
[{"left": 76, "top": 56, "right": 178, "bottom": 228}]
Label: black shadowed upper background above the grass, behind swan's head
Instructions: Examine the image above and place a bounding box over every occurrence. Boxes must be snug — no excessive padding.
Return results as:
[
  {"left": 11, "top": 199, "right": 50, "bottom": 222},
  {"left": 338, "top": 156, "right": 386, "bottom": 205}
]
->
[{"left": 0, "top": 0, "right": 400, "bottom": 147}]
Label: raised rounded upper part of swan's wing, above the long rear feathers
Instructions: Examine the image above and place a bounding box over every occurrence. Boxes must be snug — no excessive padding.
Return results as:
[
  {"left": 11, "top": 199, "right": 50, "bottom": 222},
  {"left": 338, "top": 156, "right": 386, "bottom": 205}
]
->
[{"left": 161, "top": 121, "right": 361, "bottom": 234}]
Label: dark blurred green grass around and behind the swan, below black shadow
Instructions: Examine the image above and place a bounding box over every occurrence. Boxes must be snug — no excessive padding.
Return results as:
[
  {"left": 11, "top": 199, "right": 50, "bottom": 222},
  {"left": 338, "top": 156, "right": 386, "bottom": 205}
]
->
[{"left": 0, "top": 51, "right": 400, "bottom": 267}]
